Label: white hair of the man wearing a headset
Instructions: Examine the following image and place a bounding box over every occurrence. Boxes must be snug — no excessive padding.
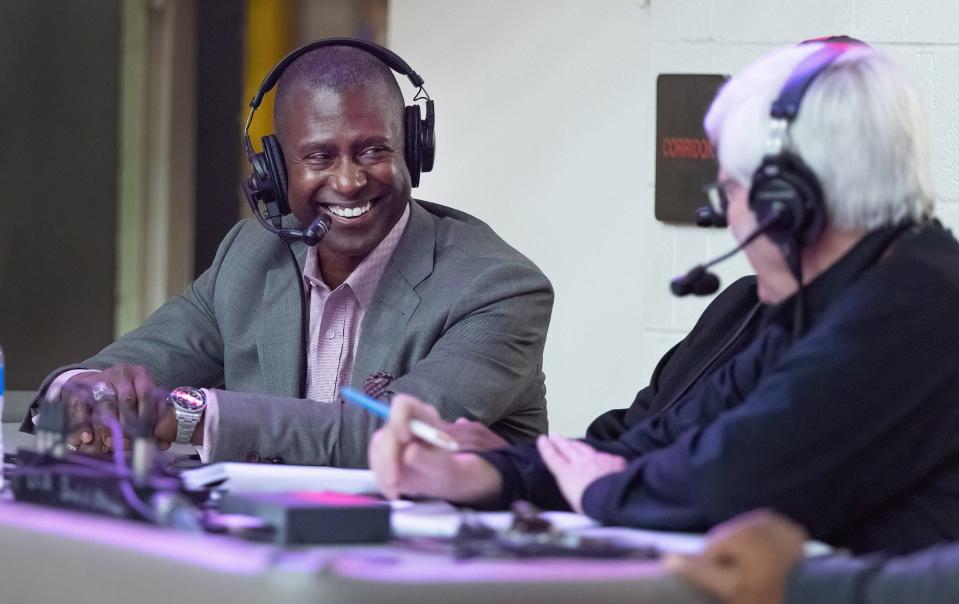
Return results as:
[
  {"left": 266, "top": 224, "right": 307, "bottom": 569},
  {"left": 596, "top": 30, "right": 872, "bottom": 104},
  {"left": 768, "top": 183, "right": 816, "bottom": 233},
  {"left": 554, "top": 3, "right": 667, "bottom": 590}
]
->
[{"left": 703, "top": 43, "right": 935, "bottom": 231}]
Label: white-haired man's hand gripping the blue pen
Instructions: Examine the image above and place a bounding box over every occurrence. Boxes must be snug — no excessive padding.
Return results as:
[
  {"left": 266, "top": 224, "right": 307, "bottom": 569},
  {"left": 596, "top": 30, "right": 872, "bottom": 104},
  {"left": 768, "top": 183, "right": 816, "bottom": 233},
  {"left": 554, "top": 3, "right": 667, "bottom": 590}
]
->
[{"left": 369, "top": 394, "right": 501, "bottom": 503}]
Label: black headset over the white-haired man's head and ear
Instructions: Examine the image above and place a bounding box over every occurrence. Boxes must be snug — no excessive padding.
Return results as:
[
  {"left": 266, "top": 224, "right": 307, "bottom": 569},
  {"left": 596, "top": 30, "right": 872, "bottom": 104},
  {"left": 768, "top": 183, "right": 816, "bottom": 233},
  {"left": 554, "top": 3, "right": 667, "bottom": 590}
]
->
[{"left": 749, "top": 36, "right": 865, "bottom": 264}]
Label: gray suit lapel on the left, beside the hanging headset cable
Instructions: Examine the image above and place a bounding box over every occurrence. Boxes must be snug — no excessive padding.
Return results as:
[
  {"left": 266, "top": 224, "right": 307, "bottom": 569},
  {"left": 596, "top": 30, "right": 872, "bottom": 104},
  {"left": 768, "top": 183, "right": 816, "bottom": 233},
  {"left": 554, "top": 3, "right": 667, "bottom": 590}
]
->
[{"left": 256, "top": 245, "right": 308, "bottom": 396}]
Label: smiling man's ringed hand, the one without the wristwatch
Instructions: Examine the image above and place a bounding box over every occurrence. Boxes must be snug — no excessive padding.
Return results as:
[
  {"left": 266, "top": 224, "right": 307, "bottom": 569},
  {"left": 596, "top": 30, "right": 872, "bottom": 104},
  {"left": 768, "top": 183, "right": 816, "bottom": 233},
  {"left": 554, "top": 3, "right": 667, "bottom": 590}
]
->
[{"left": 60, "top": 364, "right": 156, "bottom": 453}]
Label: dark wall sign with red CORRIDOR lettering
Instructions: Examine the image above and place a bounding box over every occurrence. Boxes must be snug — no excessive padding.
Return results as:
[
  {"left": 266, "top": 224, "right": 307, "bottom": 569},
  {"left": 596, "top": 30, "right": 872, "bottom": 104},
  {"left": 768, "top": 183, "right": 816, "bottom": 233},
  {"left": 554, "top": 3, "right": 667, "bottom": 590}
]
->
[{"left": 656, "top": 74, "right": 728, "bottom": 224}]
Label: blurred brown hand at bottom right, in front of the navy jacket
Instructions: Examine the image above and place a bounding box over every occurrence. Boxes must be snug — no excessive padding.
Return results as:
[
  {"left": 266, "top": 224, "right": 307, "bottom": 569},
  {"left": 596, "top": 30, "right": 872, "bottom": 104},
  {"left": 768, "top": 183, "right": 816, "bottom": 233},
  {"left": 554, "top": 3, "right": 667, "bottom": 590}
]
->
[{"left": 664, "top": 510, "right": 809, "bottom": 604}]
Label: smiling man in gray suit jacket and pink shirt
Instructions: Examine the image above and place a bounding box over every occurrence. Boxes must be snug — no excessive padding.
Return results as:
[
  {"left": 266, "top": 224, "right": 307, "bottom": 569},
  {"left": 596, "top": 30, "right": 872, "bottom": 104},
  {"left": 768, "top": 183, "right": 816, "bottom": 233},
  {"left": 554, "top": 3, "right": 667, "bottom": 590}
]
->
[{"left": 24, "top": 41, "right": 553, "bottom": 466}]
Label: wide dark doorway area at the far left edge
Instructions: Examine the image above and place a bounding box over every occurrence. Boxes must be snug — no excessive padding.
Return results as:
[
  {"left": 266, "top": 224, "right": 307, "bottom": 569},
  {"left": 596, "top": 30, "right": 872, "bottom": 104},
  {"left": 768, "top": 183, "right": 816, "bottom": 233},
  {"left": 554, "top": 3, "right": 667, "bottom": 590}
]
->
[{"left": 0, "top": 0, "right": 120, "bottom": 390}]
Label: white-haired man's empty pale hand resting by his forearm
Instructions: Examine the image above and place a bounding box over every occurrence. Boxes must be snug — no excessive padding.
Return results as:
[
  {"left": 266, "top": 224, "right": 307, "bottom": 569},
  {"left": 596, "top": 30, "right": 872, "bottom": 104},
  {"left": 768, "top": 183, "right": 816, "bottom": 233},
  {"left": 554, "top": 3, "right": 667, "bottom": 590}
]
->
[{"left": 536, "top": 435, "right": 626, "bottom": 514}]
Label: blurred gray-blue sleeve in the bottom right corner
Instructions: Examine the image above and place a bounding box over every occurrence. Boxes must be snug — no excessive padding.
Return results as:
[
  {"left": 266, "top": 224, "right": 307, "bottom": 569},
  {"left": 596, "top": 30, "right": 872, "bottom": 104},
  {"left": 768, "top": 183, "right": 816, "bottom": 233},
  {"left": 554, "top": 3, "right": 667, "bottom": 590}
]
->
[{"left": 786, "top": 543, "right": 959, "bottom": 604}]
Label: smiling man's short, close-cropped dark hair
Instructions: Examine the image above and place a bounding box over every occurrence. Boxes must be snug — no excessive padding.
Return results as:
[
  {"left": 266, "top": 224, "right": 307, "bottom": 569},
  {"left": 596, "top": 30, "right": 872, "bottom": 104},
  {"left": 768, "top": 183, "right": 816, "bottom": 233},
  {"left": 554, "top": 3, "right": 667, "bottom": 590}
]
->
[{"left": 273, "top": 46, "right": 404, "bottom": 139}]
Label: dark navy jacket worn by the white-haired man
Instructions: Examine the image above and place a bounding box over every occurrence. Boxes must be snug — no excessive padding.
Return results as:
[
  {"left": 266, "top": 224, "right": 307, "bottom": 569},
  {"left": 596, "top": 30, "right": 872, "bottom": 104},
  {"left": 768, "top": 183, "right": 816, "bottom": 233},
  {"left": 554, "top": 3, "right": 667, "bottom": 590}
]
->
[{"left": 486, "top": 223, "right": 959, "bottom": 552}]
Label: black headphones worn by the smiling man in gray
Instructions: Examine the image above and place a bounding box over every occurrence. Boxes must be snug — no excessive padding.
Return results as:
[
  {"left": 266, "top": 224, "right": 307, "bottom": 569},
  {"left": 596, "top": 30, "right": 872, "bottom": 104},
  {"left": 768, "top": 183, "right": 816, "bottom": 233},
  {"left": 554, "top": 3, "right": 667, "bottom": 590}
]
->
[{"left": 243, "top": 38, "right": 436, "bottom": 232}]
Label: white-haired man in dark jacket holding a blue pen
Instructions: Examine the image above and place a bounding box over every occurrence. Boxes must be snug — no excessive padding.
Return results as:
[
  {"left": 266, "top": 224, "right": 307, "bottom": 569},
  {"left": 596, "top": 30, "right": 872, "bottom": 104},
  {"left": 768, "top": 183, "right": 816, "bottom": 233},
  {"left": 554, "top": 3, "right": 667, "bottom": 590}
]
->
[{"left": 370, "top": 38, "right": 959, "bottom": 552}]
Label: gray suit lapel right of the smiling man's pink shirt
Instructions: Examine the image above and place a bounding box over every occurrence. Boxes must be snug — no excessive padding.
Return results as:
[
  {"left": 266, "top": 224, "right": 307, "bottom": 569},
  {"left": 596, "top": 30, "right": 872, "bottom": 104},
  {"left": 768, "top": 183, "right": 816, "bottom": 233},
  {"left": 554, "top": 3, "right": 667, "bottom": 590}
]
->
[{"left": 352, "top": 201, "right": 436, "bottom": 387}]
